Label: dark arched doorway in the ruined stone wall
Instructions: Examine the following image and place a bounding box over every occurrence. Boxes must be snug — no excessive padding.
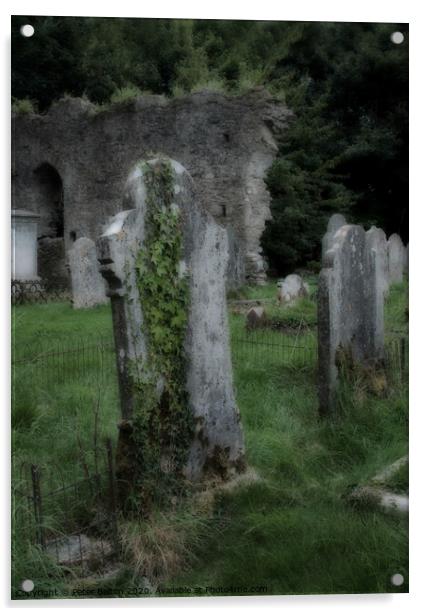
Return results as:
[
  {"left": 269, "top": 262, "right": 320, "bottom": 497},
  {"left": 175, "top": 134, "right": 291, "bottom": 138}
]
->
[{"left": 33, "top": 162, "right": 69, "bottom": 291}]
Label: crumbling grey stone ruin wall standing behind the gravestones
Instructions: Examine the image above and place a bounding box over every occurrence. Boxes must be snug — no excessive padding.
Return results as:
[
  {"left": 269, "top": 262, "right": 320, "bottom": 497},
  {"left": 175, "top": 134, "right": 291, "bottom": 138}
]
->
[{"left": 12, "top": 90, "right": 291, "bottom": 281}]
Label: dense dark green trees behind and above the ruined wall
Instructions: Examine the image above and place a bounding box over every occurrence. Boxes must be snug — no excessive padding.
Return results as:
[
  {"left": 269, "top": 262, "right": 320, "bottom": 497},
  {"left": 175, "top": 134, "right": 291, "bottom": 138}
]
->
[{"left": 12, "top": 16, "right": 408, "bottom": 273}]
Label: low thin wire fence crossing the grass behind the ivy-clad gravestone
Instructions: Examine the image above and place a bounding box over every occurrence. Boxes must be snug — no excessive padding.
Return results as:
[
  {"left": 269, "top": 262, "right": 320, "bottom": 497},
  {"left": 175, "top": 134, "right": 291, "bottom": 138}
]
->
[{"left": 12, "top": 325, "right": 408, "bottom": 387}]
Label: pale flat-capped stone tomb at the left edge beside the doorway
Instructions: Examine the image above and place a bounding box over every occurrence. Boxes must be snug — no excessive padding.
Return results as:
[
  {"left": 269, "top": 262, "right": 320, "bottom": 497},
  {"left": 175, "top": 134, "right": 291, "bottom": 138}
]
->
[{"left": 12, "top": 210, "right": 40, "bottom": 280}]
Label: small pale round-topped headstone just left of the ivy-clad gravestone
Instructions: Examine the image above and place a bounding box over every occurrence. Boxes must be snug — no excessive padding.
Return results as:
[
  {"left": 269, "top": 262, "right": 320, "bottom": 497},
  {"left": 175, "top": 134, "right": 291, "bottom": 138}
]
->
[{"left": 68, "top": 237, "right": 108, "bottom": 308}]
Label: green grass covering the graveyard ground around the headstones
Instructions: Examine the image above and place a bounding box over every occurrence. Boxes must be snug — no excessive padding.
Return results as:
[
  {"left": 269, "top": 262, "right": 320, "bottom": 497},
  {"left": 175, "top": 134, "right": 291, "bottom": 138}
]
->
[{"left": 12, "top": 280, "right": 408, "bottom": 595}]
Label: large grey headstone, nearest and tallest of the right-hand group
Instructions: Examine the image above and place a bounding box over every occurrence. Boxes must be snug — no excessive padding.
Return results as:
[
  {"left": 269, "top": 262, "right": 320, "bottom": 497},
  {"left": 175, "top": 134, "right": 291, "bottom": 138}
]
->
[{"left": 318, "top": 225, "right": 384, "bottom": 414}]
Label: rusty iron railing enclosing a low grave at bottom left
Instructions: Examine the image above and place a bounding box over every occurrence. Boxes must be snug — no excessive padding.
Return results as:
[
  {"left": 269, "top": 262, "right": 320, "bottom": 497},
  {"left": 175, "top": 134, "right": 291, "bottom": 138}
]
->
[{"left": 12, "top": 440, "right": 119, "bottom": 574}]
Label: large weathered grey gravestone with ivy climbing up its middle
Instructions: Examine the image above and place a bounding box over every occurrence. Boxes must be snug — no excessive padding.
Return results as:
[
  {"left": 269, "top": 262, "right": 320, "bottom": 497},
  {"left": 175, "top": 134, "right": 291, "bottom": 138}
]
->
[{"left": 97, "top": 158, "right": 244, "bottom": 503}]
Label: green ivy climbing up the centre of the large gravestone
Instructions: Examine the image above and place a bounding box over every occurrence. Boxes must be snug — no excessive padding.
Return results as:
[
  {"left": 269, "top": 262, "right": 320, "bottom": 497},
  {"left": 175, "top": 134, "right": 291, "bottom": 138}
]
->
[{"left": 132, "top": 158, "right": 193, "bottom": 505}]
